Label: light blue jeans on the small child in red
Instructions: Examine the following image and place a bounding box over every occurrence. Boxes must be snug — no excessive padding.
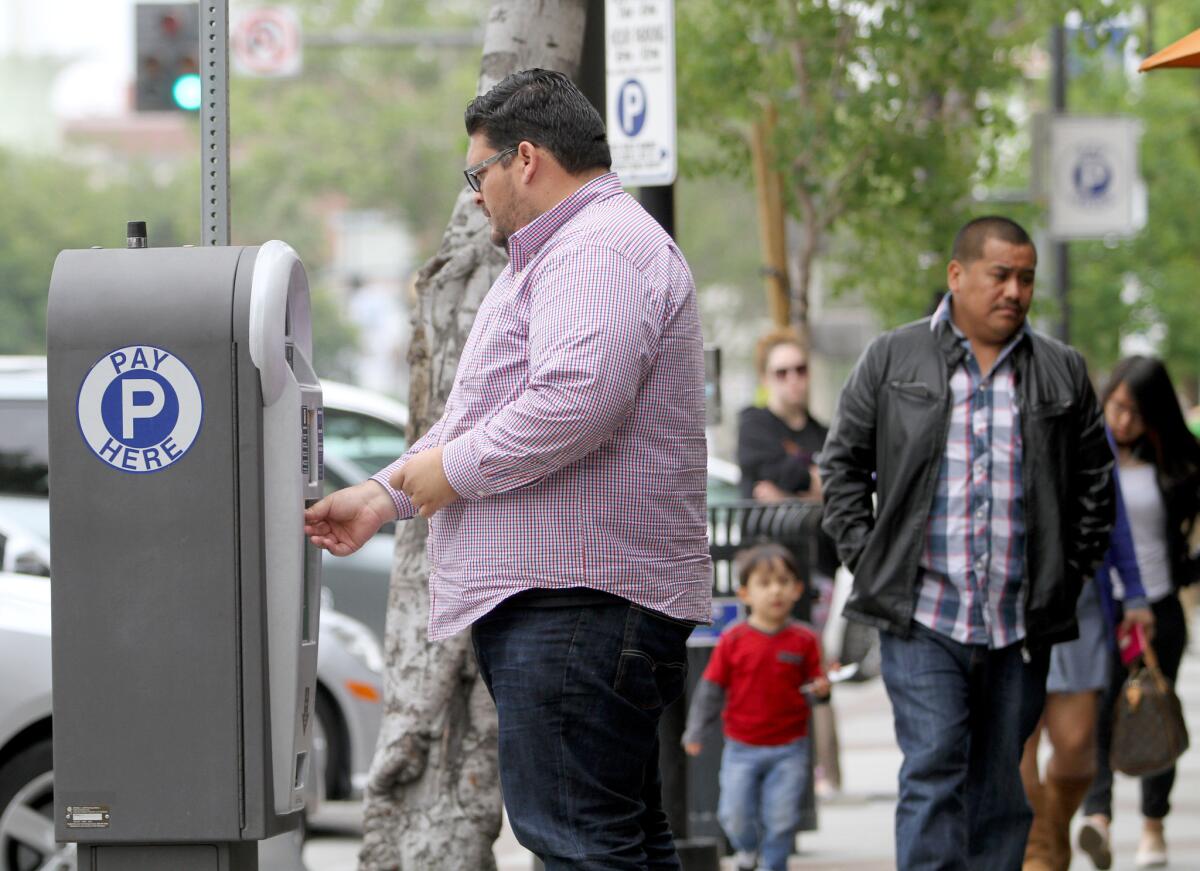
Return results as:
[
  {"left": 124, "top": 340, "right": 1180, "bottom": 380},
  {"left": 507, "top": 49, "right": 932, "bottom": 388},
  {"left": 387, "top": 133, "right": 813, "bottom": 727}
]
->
[{"left": 716, "top": 737, "right": 809, "bottom": 871}]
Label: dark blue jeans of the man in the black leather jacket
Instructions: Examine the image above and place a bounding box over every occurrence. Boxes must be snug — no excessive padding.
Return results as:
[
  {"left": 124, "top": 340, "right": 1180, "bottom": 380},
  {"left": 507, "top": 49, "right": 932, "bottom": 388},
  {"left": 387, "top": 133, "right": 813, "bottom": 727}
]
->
[{"left": 881, "top": 623, "right": 1050, "bottom": 871}]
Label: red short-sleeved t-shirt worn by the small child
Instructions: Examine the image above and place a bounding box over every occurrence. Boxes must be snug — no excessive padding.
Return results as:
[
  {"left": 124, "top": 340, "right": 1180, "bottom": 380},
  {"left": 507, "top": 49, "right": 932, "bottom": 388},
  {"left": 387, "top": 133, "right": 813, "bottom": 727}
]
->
[{"left": 704, "top": 623, "right": 823, "bottom": 746}]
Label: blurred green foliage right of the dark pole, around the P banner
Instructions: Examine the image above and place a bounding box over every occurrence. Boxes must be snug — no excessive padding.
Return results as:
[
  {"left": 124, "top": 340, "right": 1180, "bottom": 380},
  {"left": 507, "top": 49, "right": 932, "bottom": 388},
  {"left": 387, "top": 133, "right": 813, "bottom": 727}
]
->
[{"left": 1068, "top": 0, "right": 1200, "bottom": 393}]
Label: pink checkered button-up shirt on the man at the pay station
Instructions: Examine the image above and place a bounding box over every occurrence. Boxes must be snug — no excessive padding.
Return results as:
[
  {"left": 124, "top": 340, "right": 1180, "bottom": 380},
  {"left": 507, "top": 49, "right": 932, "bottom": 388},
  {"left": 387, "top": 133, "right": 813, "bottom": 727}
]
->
[{"left": 372, "top": 173, "right": 712, "bottom": 639}]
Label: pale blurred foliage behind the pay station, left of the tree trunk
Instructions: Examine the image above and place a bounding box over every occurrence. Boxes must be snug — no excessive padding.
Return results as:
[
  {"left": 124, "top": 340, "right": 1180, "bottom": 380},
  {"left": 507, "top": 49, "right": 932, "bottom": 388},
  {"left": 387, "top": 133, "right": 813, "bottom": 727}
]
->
[{"left": 0, "top": 0, "right": 487, "bottom": 377}]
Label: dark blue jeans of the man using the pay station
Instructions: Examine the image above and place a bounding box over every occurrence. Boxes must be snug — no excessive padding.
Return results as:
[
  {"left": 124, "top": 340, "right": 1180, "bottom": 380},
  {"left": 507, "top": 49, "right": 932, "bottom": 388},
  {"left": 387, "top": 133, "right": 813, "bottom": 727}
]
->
[{"left": 472, "top": 600, "right": 691, "bottom": 871}]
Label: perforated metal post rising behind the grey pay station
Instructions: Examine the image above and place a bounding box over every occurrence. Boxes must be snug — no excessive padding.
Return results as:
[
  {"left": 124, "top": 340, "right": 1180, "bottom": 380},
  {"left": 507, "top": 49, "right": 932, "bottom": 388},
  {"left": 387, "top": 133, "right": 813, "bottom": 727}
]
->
[{"left": 199, "top": 0, "right": 229, "bottom": 246}]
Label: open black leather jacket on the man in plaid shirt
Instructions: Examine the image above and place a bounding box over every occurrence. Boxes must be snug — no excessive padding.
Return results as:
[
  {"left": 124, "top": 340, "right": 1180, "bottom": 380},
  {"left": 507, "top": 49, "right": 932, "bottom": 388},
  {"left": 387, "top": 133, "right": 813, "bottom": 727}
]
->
[{"left": 820, "top": 318, "right": 1115, "bottom": 647}]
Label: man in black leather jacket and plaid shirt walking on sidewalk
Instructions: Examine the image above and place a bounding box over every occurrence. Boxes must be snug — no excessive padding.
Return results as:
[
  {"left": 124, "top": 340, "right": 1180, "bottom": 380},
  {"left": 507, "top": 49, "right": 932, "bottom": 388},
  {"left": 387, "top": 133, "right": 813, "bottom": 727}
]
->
[{"left": 820, "top": 217, "right": 1114, "bottom": 871}]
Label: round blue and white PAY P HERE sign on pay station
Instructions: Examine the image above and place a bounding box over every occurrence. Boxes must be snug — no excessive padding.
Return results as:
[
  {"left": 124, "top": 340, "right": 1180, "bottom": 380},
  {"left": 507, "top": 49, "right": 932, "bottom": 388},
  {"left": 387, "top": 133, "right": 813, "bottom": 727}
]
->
[{"left": 76, "top": 344, "right": 204, "bottom": 473}]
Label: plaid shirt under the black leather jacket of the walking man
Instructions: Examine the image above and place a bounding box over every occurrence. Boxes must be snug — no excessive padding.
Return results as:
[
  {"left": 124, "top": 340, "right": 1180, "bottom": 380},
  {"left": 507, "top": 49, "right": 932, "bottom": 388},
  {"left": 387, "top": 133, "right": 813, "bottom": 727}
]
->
[{"left": 913, "top": 294, "right": 1028, "bottom": 649}]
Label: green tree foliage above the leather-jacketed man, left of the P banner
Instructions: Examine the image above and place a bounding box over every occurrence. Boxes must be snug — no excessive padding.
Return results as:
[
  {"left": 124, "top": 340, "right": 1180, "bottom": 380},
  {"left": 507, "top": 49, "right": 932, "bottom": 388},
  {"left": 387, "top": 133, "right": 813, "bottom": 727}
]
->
[{"left": 676, "top": 0, "right": 1112, "bottom": 333}]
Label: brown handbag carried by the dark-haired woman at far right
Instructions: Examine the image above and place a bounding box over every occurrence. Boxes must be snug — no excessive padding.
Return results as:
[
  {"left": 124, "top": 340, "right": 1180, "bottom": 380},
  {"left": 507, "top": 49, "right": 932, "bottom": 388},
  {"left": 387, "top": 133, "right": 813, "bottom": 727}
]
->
[{"left": 1109, "top": 643, "right": 1188, "bottom": 777}]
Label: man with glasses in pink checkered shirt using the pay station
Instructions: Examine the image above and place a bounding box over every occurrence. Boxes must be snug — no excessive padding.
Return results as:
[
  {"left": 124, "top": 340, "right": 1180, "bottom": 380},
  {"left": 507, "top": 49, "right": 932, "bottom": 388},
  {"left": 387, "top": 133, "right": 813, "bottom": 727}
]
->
[{"left": 305, "top": 70, "right": 712, "bottom": 871}]
